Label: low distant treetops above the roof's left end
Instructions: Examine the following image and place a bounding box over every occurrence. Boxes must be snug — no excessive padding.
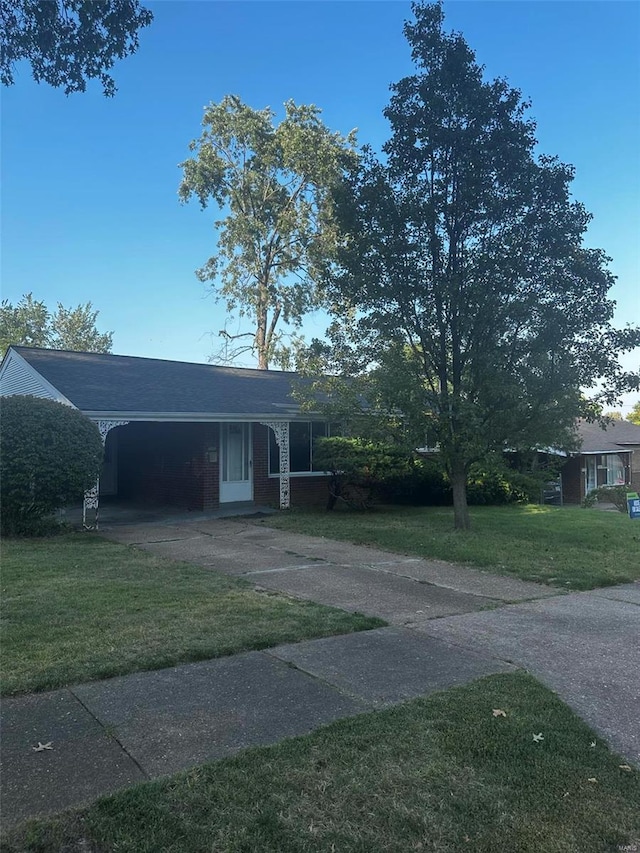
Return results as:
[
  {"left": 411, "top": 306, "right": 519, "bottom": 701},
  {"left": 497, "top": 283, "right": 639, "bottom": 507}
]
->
[{"left": 0, "top": 293, "right": 113, "bottom": 358}]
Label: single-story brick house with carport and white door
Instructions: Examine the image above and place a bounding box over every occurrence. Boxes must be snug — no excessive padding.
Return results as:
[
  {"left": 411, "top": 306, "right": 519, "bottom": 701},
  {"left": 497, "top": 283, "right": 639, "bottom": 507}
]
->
[{"left": 0, "top": 346, "right": 336, "bottom": 513}]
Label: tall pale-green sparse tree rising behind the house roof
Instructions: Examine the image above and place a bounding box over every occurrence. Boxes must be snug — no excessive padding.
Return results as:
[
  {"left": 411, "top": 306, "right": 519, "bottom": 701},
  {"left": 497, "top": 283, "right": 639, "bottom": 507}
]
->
[{"left": 179, "top": 95, "right": 355, "bottom": 368}]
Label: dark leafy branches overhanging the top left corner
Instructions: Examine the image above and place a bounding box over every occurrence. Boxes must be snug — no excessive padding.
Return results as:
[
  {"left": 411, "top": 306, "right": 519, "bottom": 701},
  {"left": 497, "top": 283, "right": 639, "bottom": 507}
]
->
[{"left": 0, "top": 0, "right": 153, "bottom": 96}]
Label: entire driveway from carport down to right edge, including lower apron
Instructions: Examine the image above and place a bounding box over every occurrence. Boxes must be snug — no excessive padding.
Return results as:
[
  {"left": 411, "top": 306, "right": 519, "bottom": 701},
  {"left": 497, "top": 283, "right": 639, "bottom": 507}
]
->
[{"left": 103, "top": 518, "right": 640, "bottom": 764}]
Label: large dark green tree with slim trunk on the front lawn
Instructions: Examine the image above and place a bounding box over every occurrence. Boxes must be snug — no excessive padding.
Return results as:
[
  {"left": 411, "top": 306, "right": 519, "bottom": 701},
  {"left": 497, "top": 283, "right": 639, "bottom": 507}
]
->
[{"left": 316, "top": 4, "right": 640, "bottom": 528}]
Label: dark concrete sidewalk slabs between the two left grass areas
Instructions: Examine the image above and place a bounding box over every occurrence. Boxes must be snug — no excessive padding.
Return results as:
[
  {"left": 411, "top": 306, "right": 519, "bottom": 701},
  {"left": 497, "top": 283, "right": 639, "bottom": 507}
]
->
[{"left": 2, "top": 628, "right": 511, "bottom": 826}]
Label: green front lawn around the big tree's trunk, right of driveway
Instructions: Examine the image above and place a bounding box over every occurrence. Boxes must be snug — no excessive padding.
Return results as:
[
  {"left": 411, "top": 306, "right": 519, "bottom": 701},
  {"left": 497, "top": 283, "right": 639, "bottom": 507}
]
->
[{"left": 264, "top": 506, "right": 640, "bottom": 590}]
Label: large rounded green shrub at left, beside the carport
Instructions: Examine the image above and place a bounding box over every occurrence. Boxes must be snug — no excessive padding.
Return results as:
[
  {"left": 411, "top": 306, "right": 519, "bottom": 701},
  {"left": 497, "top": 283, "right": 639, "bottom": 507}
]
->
[{"left": 0, "top": 396, "right": 103, "bottom": 535}]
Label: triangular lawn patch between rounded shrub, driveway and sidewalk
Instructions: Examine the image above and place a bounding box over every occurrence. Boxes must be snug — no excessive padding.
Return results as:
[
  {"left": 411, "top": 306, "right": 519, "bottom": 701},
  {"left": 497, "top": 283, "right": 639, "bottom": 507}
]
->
[{"left": 1, "top": 534, "right": 385, "bottom": 695}]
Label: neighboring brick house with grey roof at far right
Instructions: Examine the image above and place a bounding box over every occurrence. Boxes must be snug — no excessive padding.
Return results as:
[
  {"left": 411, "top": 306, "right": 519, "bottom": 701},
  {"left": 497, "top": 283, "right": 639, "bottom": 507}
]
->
[{"left": 562, "top": 421, "right": 640, "bottom": 503}]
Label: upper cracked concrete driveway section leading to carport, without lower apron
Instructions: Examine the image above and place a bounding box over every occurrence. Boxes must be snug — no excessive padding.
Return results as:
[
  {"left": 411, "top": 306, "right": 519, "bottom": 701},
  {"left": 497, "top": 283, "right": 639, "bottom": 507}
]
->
[{"left": 102, "top": 519, "right": 558, "bottom": 627}]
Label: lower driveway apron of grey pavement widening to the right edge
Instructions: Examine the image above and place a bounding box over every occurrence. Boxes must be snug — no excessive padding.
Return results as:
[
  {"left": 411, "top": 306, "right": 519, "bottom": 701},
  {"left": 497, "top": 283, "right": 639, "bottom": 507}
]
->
[{"left": 420, "top": 583, "right": 640, "bottom": 766}]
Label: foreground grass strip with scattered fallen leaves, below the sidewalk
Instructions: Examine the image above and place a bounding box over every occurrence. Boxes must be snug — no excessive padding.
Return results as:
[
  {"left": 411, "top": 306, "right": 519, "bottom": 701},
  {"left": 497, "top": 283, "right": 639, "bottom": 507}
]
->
[{"left": 3, "top": 673, "right": 640, "bottom": 853}]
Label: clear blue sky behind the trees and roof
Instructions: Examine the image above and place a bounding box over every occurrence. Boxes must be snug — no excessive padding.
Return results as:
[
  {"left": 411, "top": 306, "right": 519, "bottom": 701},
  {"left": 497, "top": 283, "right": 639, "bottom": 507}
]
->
[{"left": 2, "top": 0, "right": 640, "bottom": 406}]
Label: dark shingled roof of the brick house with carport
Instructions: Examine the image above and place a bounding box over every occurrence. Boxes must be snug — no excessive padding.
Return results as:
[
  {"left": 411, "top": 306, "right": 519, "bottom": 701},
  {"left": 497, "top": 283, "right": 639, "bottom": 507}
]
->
[{"left": 0, "top": 346, "right": 310, "bottom": 418}]
